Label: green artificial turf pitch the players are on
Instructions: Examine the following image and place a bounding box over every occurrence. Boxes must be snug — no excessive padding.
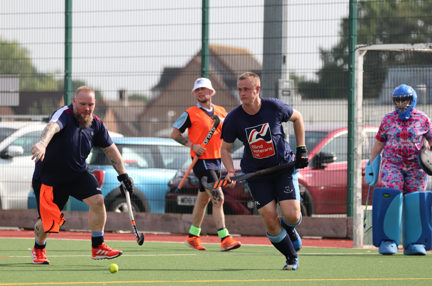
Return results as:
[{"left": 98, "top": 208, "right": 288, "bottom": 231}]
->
[{"left": 0, "top": 238, "right": 432, "bottom": 286}]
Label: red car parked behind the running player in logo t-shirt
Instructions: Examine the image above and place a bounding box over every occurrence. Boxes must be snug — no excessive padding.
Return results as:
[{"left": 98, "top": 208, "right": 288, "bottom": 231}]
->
[{"left": 165, "top": 126, "right": 380, "bottom": 216}]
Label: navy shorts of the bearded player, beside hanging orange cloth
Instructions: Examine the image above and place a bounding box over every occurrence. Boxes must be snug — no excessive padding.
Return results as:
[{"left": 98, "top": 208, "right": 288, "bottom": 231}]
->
[{"left": 32, "top": 170, "right": 102, "bottom": 216}]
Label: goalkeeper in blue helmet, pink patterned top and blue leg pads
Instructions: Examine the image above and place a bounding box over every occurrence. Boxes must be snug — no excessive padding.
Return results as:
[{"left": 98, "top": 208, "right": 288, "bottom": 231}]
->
[{"left": 366, "top": 84, "right": 432, "bottom": 255}]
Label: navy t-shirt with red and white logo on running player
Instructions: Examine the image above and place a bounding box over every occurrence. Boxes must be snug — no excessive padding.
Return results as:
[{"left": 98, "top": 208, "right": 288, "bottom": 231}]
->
[{"left": 221, "top": 98, "right": 294, "bottom": 175}]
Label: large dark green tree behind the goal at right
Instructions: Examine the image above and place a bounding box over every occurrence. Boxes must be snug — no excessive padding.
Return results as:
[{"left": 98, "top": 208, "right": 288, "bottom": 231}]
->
[{"left": 298, "top": 0, "right": 432, "bottom": 98}]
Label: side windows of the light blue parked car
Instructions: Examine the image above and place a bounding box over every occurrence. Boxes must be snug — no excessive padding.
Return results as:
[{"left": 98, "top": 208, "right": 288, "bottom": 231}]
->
[{"left": 87, "top": 144, "right": 192, "bottom": 170}]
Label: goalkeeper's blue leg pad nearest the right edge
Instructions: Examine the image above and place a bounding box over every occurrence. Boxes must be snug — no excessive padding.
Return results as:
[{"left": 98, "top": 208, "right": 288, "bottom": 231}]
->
[{"left": 402, "top": 191, "right": 432, "bottom": 251}]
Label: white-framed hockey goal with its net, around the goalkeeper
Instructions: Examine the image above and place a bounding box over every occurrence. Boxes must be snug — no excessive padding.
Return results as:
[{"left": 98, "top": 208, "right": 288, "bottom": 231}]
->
[{"left": 353, "top": 43, "right": 432, "bottom": 248}]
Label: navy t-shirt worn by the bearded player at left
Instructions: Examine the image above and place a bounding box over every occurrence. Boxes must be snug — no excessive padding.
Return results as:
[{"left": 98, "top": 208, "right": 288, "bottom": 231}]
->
[{"left": 33, "top": 104, "right": 113, "bottom": 187}]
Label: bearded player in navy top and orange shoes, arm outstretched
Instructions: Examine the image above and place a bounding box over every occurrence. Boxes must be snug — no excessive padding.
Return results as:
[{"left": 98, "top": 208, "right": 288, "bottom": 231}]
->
[{"left": 31, "top": 86, "right": 133, "bottom": 264}]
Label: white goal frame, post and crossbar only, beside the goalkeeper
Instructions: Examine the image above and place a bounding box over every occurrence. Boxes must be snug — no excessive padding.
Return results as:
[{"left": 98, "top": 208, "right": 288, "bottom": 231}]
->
[{"left": 353, "top": 43, "right": 432, "bottom": 248}]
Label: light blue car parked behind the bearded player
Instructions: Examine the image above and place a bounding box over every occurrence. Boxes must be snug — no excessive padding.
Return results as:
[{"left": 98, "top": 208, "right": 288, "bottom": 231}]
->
[{"left": 28, "top": 137, "right": 192, "bottom": 213}]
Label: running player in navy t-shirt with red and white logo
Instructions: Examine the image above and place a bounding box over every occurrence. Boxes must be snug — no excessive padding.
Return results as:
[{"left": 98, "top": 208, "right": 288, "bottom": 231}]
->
[{"left": 221, "top": 72, "right": 308, "bottom": 270}]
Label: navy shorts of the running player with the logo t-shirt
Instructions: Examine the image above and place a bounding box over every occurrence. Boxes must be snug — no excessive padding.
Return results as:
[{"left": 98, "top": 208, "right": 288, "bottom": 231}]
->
[{"left": 245, "top": 167, "right": 301, "bottom": 209}]
